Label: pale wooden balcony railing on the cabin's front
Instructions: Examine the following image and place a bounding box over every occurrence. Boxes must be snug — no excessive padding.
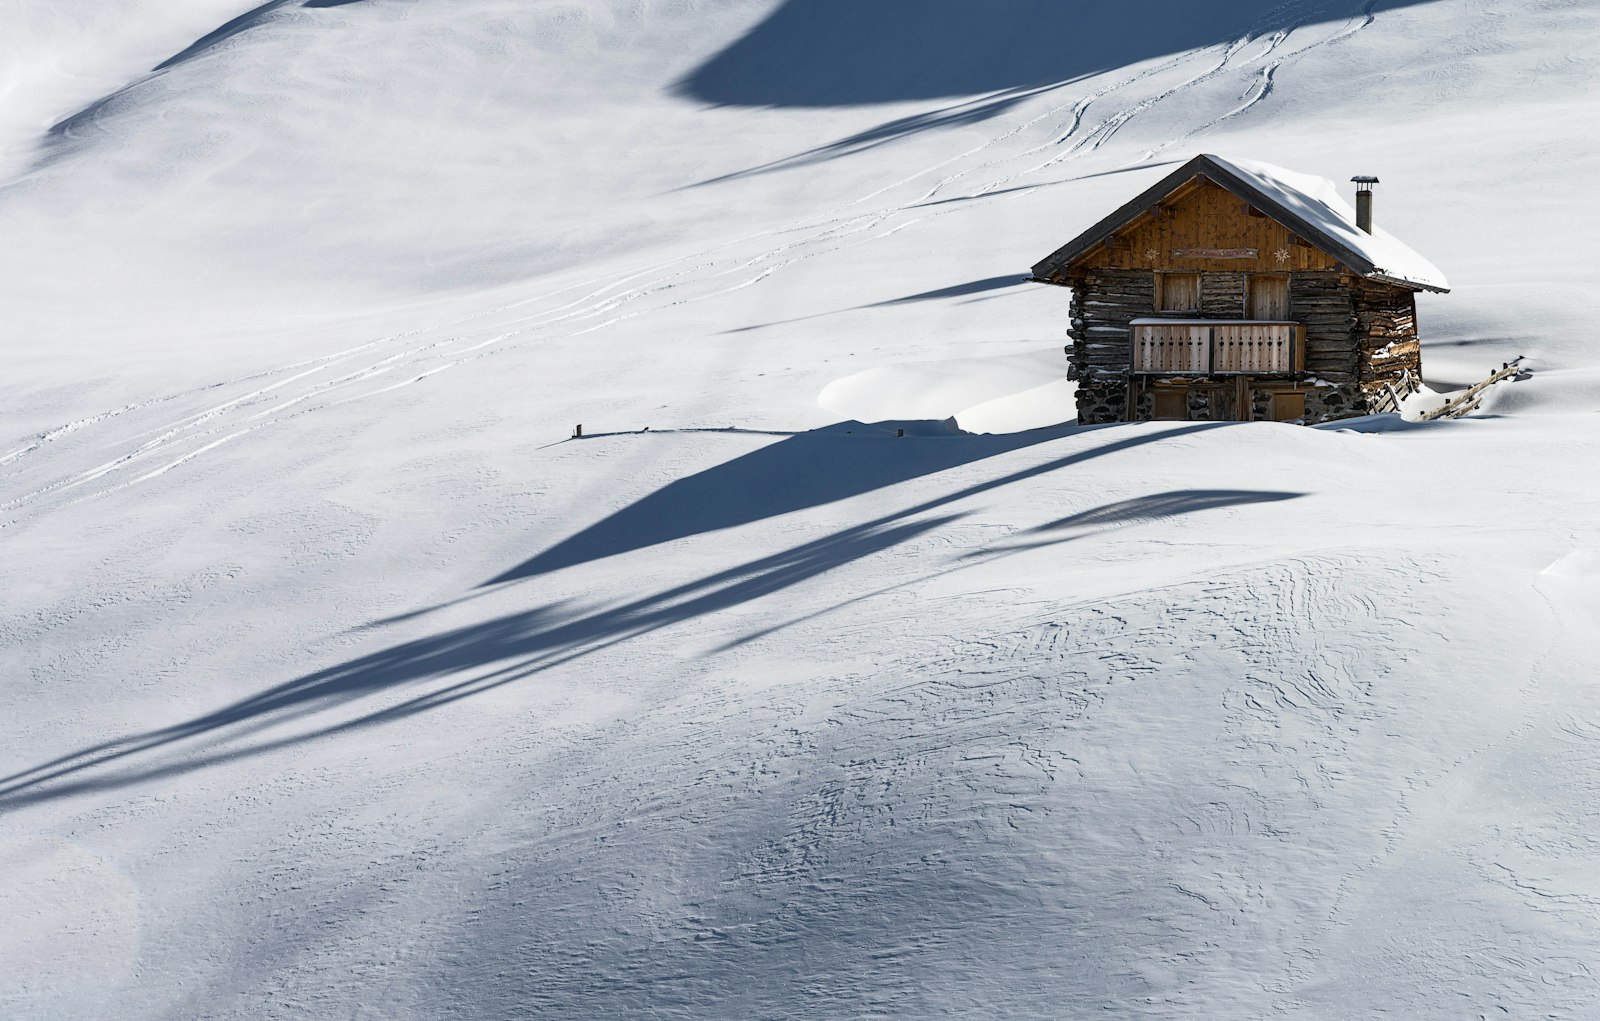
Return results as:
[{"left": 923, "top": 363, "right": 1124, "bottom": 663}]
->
[{"left": 1133, "top": 318, "right": 1304, "bottom": 376}]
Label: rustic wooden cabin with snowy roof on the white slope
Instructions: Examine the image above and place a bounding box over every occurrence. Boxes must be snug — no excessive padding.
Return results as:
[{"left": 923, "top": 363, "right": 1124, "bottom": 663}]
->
[{"left": 1034, "top": 155, "right": 1450, "bottom": 424}]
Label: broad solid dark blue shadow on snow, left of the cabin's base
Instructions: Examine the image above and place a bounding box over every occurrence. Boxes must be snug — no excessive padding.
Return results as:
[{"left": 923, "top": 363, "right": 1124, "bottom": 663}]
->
[{"left": 483, "top": 422, "right": 1066, "bottom": 586}]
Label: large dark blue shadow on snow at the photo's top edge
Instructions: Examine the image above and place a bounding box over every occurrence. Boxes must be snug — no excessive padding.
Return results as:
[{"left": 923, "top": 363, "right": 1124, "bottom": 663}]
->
[{"left": 674, "top": 0, "right": 1435, "bottom": 107}]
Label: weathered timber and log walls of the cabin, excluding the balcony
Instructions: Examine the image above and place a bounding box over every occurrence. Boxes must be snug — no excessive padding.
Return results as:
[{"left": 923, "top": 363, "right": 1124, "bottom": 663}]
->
[{"left": 1053, "top": 179, "right": 1421, "bottom": 424}]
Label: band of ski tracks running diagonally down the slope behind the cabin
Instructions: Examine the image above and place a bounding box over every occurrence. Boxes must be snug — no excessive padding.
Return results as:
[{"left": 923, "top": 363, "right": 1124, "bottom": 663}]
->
[{"left": 0, "top": 0, "right": 1376, "bottom": 528}]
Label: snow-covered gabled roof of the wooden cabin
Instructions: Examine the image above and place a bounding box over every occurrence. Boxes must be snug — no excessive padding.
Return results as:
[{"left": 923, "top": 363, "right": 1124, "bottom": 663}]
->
[{"left": 1034, "top": 154, "right": 1450, "bottom": 293}]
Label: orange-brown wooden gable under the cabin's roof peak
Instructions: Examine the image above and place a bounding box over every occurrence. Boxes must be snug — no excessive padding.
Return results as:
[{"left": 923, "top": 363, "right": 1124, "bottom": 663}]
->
[{"left": 1064, "top": 176, "right": 1341, "bottom": 275}]
